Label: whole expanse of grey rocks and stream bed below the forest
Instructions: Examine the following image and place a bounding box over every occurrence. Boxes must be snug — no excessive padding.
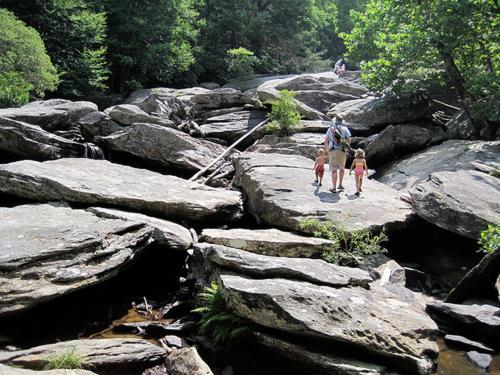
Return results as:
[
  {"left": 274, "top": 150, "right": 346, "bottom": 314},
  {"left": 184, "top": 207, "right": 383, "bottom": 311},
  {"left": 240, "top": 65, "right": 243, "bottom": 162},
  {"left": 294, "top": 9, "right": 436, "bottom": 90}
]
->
[{"left": 0, "top": 72, "right": 500, "bottom": 375}]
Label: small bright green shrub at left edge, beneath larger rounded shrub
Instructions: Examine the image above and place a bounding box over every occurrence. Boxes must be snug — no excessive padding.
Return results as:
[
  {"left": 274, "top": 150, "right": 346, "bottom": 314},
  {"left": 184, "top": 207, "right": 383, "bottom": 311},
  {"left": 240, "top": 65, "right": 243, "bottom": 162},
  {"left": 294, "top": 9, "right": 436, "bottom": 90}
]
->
[{"left": 0, "top": 72, "right": 33, "bottom": 108}]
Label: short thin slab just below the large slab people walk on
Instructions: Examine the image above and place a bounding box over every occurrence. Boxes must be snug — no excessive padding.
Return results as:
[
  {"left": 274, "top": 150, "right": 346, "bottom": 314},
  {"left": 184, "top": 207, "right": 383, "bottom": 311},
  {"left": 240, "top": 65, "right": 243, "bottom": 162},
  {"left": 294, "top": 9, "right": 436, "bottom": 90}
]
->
[{"left": 201, "top": 229, "right": 331, "bottom": 258}]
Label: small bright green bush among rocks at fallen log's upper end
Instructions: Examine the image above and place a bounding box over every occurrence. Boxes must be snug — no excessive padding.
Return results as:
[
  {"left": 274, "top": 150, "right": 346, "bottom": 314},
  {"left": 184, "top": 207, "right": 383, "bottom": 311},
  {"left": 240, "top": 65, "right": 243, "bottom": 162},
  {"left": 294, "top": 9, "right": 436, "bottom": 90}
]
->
[{"left": 267, "top": 90, "right": 300, "bottom": 136}]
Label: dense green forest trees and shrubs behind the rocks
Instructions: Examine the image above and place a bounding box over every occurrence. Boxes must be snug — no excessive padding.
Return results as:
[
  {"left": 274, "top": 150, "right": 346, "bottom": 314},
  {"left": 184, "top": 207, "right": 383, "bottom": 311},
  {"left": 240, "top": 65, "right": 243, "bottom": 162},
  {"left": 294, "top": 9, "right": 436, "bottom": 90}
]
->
[{"left": 0, "top": 0, "right": 500, "bottom": 131}]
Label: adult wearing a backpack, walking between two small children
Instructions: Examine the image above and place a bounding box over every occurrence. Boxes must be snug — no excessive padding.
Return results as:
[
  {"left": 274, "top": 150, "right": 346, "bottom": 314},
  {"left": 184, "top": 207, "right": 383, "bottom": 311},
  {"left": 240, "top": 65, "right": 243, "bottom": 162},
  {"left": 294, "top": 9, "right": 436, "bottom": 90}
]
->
[{"left": 325, "top": 117, "right": 351, "bottom": 193}]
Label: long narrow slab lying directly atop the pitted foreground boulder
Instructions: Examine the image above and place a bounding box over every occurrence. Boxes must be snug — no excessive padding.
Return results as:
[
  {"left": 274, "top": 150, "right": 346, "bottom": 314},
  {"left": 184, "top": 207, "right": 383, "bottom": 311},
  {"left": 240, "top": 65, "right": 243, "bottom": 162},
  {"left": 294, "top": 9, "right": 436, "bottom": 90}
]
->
[{"left": 195, "top": 243, "right": 373, "bottom": 287}]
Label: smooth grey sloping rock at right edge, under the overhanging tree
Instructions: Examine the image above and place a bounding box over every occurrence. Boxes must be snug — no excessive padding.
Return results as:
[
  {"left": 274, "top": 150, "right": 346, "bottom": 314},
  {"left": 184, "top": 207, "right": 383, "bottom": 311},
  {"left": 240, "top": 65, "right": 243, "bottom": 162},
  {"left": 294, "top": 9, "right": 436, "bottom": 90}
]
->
[{"left": 376, "top": 141, "right": 500, "bottom": 190}]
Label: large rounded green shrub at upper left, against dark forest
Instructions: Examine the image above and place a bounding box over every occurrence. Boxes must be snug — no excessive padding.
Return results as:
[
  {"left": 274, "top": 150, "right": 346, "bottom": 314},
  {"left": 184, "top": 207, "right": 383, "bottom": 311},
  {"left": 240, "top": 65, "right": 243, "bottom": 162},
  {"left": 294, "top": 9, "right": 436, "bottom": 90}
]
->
[{"left": 0, "top": 9, "right": 59, "bottom": 101}]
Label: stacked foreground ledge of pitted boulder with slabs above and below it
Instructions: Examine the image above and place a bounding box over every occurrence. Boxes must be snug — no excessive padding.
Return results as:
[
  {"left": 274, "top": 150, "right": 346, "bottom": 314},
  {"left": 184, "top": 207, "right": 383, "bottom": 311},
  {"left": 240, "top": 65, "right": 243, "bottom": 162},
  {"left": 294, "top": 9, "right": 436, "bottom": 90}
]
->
[{"left": 190, "top": 243, "right": 438, "bottom": 374}]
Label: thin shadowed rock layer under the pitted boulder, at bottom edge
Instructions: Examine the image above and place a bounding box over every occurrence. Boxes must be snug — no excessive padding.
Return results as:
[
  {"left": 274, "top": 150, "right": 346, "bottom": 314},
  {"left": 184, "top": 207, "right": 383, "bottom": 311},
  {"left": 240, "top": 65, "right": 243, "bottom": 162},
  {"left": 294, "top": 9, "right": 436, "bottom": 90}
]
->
[{"left": 254, "top": 332, "right": 387, "bottom": 375}]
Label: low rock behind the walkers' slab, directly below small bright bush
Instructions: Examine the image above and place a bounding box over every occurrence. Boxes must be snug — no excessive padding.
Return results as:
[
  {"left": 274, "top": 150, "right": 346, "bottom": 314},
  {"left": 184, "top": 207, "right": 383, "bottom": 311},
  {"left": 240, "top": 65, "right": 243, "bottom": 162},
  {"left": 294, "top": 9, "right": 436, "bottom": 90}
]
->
[{"left": 248, "top": 133, "right": 325, "bottom": 160}]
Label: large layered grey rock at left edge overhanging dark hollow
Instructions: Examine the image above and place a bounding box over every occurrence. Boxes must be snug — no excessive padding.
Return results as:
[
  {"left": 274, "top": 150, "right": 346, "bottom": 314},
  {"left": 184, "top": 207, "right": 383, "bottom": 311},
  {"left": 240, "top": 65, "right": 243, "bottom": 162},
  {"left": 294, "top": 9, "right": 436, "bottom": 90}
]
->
[{"left": 0, "top": 204, "right": 152, "bottom": 315}]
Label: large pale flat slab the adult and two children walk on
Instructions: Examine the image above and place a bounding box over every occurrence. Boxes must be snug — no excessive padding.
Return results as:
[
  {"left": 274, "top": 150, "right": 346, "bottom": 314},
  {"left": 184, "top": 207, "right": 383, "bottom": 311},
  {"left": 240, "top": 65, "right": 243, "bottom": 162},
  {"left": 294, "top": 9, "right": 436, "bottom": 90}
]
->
[{"left": 234, "top": 153, "right": 412, "bottom": 234}]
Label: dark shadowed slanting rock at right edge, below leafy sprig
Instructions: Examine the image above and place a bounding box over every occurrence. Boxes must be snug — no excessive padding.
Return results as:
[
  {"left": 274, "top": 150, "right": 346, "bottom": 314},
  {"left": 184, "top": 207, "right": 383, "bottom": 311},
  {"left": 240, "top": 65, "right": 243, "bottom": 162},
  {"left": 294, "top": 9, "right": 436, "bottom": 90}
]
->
[{"left": 445, "top": 250, "right": 500, "bottom": 303}]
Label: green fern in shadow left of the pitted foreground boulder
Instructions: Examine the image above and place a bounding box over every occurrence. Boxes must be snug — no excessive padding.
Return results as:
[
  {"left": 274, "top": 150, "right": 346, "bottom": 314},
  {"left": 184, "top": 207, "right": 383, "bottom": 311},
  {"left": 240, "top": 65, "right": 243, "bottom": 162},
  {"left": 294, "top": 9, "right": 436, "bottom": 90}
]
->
[{"left": 193, "top": 281, "right": 248, "bottom": 344}]
